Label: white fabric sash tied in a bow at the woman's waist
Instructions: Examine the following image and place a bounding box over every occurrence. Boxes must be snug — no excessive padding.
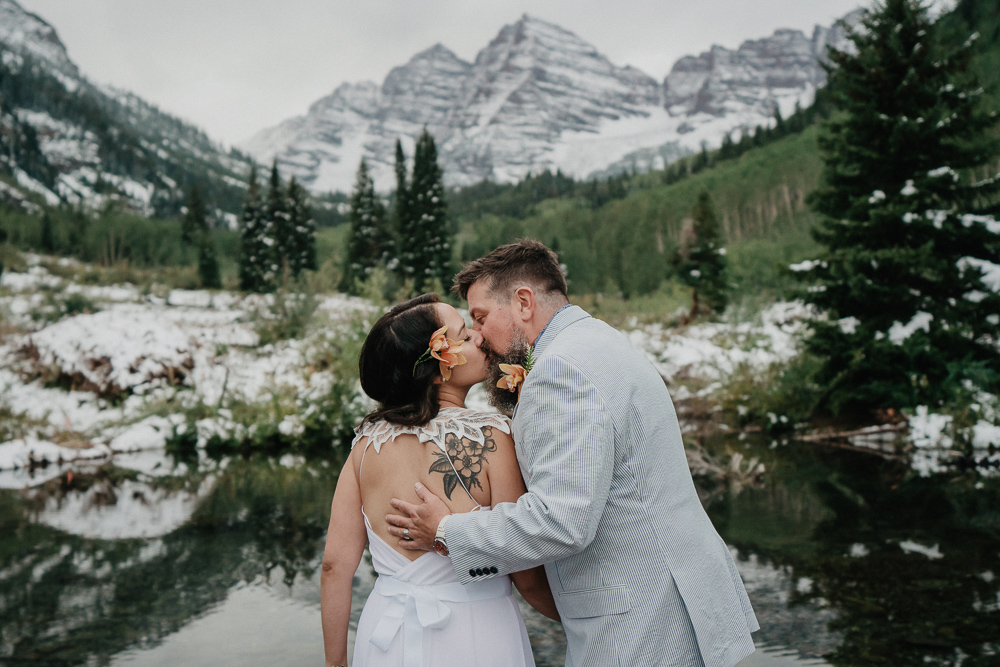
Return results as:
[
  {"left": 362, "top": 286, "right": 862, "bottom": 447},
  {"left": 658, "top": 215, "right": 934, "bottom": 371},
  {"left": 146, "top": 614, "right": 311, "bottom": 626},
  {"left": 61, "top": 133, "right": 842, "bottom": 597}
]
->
[{"left": 370, "top": 576, "right": 510, "bottom": 667}]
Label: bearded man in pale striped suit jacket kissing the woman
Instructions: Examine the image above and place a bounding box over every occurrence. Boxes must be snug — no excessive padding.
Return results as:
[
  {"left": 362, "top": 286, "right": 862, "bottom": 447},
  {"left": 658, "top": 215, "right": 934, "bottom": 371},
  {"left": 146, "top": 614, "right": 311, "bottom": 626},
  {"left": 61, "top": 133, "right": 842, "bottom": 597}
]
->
[{"left": 386, "top": 240, "right": 759, "bottom": 667}]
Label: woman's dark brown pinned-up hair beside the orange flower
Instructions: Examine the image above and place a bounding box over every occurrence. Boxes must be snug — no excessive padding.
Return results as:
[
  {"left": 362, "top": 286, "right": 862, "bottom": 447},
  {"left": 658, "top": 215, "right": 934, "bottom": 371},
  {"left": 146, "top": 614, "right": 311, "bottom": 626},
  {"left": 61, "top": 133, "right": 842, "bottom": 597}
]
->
[{"left": 358, "top": 294, "right": 442, "bottom": 426}]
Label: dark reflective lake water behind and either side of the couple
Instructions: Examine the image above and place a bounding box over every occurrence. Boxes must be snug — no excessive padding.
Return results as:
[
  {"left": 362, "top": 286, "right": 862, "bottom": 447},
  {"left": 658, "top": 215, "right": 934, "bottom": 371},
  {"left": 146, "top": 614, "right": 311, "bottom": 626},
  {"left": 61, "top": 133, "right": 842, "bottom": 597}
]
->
[{"left": 0, "top": 438, "right": 1000, "bottom": 667}]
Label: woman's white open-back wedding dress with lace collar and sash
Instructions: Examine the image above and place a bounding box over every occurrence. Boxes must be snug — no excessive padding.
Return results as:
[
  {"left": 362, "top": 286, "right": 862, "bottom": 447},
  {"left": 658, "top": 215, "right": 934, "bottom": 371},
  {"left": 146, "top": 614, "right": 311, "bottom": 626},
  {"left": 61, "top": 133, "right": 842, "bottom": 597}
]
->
[{"left": 351, "top": 408, "right": 535, "bottom": 667}]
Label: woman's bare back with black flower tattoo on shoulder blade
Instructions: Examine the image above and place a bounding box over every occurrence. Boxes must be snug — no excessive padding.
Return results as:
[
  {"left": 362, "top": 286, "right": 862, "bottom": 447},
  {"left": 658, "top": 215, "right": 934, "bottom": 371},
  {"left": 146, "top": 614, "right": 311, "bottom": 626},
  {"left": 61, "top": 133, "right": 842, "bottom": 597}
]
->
[{"left": 352, "top": 426, "right": 513, "bottom": 560}]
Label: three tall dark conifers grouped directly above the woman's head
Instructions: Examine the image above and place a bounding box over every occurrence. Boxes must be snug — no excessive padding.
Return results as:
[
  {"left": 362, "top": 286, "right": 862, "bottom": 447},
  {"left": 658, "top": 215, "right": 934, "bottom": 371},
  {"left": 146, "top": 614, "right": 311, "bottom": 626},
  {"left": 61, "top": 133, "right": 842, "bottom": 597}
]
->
[{"left": 341, "top": 128, "right": 454, "bottom": 293}]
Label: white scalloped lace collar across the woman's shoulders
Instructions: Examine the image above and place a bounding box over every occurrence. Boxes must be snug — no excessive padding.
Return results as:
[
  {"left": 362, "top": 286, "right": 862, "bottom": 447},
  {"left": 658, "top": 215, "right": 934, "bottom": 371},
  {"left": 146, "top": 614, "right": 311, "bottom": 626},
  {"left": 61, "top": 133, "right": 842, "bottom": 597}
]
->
[{"left": 351, "top": 408, "right": 510, "bottom": 454}]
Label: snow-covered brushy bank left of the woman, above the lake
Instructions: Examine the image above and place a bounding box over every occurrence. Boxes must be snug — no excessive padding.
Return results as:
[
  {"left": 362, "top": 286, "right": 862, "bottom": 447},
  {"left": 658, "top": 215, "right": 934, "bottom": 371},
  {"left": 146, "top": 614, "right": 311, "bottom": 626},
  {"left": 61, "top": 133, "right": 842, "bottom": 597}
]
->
[{"left": 0, "top": 264, "right": 377, "bottom": 488}]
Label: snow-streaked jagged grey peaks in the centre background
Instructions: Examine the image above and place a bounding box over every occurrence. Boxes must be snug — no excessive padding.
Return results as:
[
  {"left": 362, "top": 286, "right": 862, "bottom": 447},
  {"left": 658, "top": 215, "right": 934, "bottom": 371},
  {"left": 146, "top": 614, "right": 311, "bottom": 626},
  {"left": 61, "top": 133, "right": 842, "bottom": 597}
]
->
[{"left": 244, "top": 12, "right": 857, "bottom": 191}]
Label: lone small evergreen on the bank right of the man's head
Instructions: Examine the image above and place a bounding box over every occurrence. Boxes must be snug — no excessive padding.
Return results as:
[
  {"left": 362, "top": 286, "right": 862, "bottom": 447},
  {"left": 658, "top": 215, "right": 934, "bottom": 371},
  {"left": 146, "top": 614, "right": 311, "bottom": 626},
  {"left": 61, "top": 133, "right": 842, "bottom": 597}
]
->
[{"left": 675, "top": 190, "right": 729, "bottom": 322}]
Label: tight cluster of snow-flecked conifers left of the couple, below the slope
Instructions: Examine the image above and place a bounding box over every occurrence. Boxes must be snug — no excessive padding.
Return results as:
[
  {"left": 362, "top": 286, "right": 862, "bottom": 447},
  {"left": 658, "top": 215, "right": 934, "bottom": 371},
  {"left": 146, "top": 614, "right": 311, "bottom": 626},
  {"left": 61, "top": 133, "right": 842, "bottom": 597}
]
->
[{"left": 239, "top": 160, "right": 316, "bottom": 292}]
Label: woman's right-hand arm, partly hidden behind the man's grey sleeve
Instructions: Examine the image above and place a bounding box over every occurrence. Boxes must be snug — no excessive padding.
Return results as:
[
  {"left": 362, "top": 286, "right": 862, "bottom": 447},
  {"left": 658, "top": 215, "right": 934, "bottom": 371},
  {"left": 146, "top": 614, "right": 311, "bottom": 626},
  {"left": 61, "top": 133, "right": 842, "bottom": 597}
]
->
[{"left": 486, "top": 429, "right": 560, "bottom": 621}]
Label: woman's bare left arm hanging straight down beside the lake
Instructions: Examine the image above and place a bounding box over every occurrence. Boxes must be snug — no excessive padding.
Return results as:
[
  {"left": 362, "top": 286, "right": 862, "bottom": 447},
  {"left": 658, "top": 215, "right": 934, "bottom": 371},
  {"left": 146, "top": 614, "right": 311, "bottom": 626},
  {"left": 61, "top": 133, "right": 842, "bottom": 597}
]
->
[{"left": 320, "top": 456, "right": 368, "bottom": 667}]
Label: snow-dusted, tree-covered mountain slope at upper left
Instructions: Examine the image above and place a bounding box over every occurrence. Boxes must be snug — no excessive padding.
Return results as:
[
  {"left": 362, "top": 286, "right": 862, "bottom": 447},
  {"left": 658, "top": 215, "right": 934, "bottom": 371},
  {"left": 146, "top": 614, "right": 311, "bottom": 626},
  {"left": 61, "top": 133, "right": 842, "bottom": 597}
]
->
[{"left": 0, "top": 0, "right": 249, "bottom": 217}]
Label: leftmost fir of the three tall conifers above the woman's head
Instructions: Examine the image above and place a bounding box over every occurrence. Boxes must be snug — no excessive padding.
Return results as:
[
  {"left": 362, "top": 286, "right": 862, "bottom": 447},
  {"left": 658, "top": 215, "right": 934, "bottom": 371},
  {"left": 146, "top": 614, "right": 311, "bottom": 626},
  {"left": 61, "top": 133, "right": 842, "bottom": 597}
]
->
[{"left": 341, "top": 158, "right": 392, "bottom": 292}]
